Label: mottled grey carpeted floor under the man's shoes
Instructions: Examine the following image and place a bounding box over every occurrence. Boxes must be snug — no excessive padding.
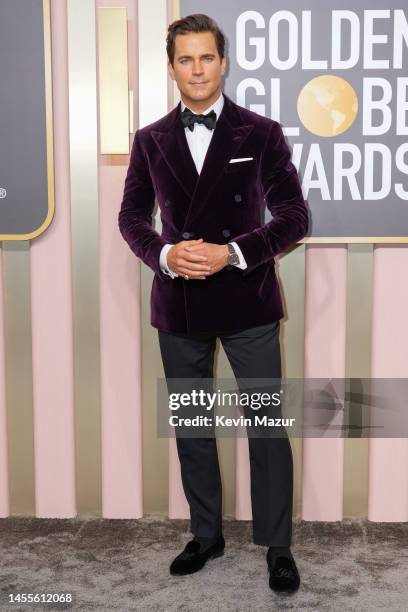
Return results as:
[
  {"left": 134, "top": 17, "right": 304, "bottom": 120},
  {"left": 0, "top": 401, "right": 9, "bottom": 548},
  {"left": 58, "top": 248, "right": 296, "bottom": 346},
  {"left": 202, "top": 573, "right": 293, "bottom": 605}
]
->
[{"left": 0, "top": 516, "right": 408, "bottom": 612}]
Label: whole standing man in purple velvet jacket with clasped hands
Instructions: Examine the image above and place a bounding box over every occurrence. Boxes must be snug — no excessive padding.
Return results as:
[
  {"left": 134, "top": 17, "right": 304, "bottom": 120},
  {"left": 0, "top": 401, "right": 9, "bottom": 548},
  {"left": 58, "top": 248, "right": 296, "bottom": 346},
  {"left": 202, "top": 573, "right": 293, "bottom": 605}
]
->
[{"left": 119, "top": 14, "right": 308, "bottom": 592}]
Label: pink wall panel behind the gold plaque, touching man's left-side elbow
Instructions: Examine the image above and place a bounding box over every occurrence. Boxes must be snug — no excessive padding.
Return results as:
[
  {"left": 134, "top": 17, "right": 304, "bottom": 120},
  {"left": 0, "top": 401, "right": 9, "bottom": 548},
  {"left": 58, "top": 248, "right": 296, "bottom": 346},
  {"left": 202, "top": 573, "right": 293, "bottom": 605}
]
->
[{"left": 96, "top": 0, "right": 143, "bottom": 518}]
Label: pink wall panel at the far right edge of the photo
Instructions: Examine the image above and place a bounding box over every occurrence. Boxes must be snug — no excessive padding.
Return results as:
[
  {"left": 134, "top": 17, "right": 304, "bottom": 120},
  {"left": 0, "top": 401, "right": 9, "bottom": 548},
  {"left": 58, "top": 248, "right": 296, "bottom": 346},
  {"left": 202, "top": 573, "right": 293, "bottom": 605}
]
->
[{"left": 368, "top": 245, "right": 408, "bottom": 521}]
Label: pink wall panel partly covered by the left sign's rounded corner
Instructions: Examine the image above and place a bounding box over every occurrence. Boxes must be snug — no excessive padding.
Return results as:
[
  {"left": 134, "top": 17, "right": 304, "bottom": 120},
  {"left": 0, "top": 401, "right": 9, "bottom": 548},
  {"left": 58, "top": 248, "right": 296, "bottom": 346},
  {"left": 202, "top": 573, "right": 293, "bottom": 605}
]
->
[{"left": 30, "top": 2, "right": 76, "bottom": 518}]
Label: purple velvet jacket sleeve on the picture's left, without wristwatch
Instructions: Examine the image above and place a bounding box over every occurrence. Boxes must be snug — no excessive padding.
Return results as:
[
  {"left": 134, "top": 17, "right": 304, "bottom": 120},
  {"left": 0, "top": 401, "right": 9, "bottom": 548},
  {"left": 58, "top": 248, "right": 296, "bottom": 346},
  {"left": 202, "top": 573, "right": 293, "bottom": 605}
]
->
[{"left": 118, "top": 130, "right": 169, "bottom": 279}]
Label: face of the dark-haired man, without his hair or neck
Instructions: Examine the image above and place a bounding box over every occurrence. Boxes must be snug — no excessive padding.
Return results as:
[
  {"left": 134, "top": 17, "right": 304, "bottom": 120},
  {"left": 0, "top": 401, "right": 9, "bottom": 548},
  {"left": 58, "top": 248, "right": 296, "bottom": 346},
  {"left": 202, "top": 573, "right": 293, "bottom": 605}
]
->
[{"left": 168, "top": 32, "right": 226, "bottom": 104}]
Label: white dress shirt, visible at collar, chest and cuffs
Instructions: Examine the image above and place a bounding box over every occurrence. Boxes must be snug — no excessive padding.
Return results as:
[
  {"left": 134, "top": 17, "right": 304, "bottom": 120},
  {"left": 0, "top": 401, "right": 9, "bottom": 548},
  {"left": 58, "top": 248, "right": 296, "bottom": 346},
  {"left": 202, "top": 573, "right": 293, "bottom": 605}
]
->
[{"left": 160, "top": 93, "right": 247, "bottom": 278}]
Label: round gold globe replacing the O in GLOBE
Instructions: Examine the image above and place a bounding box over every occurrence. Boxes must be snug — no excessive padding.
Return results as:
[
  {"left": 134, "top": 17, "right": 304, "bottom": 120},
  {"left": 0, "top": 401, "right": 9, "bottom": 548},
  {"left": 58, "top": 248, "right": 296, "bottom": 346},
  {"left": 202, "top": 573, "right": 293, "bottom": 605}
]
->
[{"left": 297, "top": 74, "right": 358, "bottom": 137}]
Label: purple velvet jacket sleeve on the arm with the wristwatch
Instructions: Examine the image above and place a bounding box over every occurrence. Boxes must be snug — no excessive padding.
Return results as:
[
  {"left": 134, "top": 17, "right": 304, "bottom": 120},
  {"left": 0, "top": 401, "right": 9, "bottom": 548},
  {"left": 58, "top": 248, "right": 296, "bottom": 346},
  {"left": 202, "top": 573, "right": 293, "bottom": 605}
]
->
[{"left": 231, "top": 121, "right": 309, "bottom": 275}]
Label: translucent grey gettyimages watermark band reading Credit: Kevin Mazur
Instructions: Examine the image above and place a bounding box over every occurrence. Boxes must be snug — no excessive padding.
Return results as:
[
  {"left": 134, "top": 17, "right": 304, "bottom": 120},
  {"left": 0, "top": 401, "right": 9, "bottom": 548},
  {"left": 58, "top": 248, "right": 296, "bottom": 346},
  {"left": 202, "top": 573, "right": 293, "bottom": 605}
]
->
[{"left": 157, "top": 378, "right": 408, "bottom": 438}]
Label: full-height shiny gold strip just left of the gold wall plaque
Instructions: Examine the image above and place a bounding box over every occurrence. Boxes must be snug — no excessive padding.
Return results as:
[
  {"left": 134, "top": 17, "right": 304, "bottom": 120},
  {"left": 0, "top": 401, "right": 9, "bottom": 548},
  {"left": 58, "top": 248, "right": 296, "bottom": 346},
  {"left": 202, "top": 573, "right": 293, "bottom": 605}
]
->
[{"left": 67, "top": 0, "right": 102, "bottom": 515}]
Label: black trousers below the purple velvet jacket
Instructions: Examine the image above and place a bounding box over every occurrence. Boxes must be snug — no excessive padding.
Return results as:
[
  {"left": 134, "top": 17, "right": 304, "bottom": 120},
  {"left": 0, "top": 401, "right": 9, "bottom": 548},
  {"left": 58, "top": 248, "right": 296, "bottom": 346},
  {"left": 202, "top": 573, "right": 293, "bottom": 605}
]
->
[{"left": 158, "top": 321, "right": 293, "bottom": 546}]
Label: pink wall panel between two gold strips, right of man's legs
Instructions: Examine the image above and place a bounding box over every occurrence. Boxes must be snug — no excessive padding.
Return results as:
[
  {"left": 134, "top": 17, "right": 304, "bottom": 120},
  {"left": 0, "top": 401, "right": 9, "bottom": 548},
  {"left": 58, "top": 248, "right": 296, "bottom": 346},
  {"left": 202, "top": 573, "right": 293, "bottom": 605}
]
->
[{"left": 302, "top": 245, "right": 347, "bottom": 521}]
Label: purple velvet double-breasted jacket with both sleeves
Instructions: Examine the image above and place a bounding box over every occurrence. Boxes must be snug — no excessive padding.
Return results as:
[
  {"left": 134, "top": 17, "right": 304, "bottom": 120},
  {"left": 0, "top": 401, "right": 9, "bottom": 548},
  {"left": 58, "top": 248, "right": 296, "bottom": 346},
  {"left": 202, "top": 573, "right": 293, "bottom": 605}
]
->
[{"left": 118, "top": 94, "right": 308, "bottom": 334}]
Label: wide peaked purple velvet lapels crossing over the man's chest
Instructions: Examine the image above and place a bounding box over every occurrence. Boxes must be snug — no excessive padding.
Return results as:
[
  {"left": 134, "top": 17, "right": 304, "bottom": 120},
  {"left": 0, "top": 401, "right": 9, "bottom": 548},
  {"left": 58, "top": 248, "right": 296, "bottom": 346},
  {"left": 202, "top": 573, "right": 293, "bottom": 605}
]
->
[{"left": 152, "top": 94, "right": 254, "bottom": 231}]
